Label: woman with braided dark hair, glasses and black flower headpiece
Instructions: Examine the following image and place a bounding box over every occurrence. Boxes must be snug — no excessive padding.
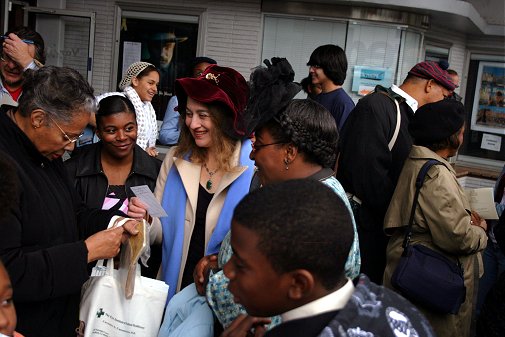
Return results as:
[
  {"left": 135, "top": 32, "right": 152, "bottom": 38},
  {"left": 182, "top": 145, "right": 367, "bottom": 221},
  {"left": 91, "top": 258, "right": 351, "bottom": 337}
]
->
[{"left": 159, "top": 58, "right": 361, "bottom": 337}]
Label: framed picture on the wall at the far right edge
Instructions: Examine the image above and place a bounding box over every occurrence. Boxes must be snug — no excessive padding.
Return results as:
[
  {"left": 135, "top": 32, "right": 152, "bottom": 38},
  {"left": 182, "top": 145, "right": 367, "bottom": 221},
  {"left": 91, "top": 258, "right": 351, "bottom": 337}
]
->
[{"left": 470, "top": 62, "right": 505, "bottom": 135}]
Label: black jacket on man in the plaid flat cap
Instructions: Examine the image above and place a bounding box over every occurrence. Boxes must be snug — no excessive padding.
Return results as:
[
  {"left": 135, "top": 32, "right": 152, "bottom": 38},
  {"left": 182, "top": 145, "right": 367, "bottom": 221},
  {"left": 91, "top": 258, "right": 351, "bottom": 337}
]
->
[{"left": 337, "top": 87, "right": 414, "bottom": 231}]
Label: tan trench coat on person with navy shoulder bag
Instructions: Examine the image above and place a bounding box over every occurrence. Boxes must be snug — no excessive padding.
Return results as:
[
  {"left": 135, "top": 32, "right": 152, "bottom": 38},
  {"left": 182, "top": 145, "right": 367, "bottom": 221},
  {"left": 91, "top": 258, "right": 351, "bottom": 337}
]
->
[{"left": 384, "top": 146, "right": 487, "bottom": 337}]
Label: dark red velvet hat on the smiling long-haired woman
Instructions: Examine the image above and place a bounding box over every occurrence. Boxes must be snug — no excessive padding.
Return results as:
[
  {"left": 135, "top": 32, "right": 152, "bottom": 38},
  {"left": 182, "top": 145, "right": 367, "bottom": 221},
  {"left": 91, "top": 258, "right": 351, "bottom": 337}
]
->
[{"left": 175, "top": 64, "right": 249, "bottom": 139}]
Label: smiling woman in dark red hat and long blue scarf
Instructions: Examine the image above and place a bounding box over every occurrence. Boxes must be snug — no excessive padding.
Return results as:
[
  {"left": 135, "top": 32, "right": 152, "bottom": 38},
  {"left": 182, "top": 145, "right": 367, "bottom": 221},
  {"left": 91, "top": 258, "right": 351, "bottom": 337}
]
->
[{"left": 129, "top": 65, "right": 254, "bottom": 299}]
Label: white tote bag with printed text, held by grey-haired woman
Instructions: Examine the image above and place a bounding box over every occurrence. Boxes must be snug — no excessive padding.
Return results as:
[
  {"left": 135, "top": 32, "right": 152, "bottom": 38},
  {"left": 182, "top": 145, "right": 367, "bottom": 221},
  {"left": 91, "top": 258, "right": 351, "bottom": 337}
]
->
[{"left": 78, "top": 259, "right": 168, "bottom": 337}]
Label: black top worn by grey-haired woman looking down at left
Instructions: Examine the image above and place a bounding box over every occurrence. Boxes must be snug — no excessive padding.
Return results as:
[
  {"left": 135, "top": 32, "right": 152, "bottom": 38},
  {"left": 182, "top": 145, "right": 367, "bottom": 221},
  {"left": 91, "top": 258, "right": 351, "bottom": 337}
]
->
[{"left": 0, "top": 106, "right": 122, "bottom": 337}]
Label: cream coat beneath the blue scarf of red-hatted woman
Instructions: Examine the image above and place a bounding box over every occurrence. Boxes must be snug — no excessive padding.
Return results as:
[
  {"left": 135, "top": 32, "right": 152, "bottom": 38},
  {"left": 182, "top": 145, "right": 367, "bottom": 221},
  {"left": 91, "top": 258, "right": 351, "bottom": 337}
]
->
[{"left": 150, "top": 141, "right": 247, "bottom": 291}]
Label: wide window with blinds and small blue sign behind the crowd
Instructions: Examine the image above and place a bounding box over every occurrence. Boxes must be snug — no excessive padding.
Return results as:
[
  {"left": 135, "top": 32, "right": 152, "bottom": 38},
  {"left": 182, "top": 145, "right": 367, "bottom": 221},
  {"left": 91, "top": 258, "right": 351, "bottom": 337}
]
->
[{"left": 262, "top": 15, "right": 422, "bottom": 102}]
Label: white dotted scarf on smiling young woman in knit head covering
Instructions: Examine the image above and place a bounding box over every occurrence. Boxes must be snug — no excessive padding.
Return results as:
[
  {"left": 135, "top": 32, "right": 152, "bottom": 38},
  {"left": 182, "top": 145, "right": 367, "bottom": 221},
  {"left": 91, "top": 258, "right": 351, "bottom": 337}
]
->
[{"left": 123, "top": 86, "right": 158, "bottom": 150}]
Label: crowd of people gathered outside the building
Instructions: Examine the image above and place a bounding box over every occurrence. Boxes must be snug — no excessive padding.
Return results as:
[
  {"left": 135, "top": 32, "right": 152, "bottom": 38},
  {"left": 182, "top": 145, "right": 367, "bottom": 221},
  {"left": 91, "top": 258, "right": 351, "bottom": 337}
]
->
[{"left": 0, "top": 27, "right": 505, "bottom": 337}]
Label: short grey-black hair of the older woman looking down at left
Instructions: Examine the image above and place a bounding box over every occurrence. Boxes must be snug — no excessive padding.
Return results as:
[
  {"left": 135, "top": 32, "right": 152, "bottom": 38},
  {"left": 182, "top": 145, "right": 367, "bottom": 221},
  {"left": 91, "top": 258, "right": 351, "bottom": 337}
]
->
[{"left": 18, "top": 66, "right": 96, "bottom": 123}]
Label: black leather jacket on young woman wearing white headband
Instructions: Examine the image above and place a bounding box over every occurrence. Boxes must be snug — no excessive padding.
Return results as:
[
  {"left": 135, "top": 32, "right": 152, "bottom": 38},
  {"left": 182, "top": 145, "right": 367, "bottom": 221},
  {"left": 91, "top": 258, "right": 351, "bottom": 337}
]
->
[{"left": 65, "top": 142, "right": 161, "bottom": 208}]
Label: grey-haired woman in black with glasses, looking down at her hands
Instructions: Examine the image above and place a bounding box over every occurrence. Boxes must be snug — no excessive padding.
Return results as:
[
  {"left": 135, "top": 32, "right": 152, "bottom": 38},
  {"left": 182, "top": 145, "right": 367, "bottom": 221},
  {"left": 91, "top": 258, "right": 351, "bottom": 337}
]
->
[{"left": 0, "top": 66, "right": 137, "bottom": 336}]
